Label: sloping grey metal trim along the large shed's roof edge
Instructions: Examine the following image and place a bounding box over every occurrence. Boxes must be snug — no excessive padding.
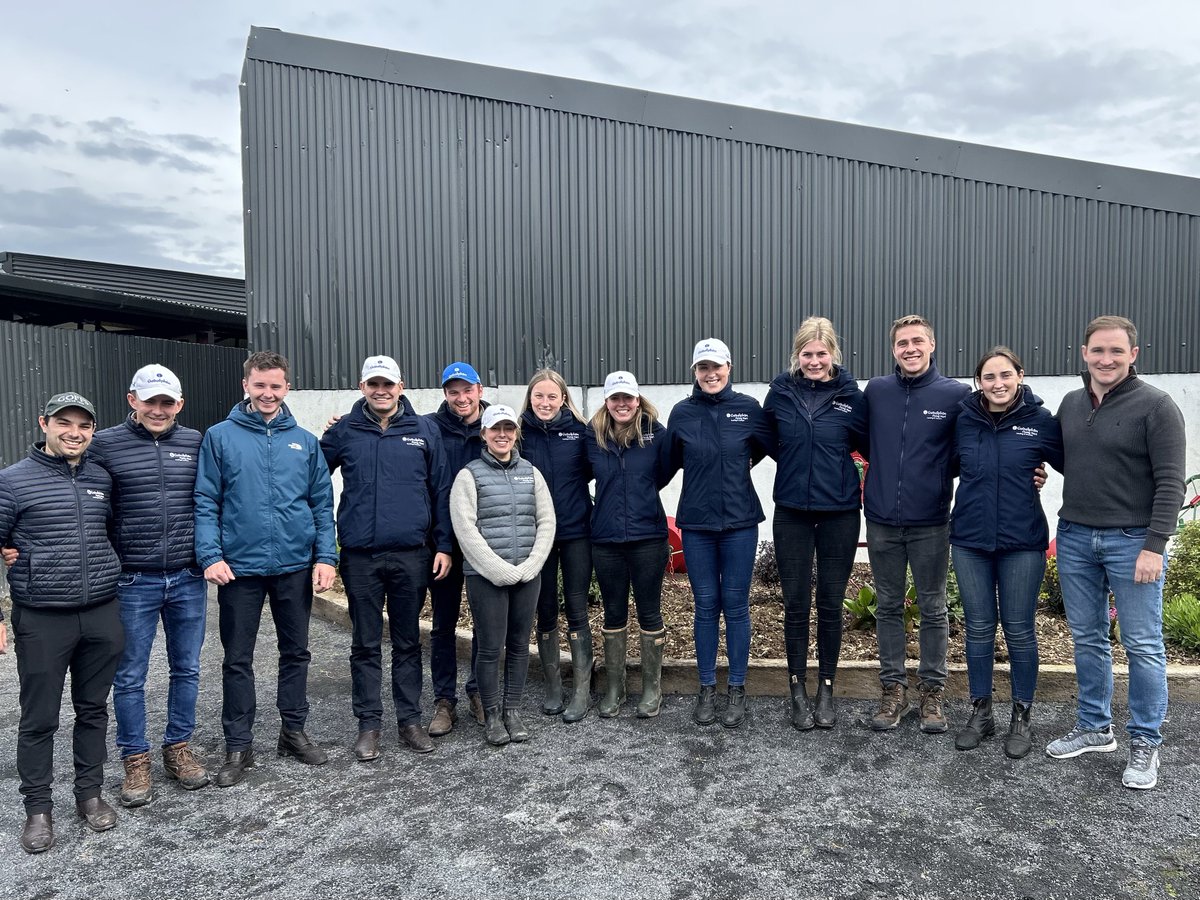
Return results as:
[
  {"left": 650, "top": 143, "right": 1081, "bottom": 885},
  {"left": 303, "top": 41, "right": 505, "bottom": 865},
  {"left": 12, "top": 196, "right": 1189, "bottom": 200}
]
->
[{"left": 246, "top": 26, "right": 1200, "bottom": 215}]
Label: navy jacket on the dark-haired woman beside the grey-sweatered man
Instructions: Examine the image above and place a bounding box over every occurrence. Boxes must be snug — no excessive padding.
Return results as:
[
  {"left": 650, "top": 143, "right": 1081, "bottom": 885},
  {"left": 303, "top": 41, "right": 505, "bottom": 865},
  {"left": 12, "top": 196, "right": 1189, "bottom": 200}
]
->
[{"left": 950, "top": 384, "right": 1063, "bottom": 552}]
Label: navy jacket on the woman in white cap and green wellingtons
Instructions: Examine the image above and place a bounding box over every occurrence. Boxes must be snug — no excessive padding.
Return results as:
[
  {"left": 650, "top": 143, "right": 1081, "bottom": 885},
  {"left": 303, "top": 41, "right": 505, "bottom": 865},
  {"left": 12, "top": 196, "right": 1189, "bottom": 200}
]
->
[{"left": 584, "top": 415, "right": 671, "bottom": 544}]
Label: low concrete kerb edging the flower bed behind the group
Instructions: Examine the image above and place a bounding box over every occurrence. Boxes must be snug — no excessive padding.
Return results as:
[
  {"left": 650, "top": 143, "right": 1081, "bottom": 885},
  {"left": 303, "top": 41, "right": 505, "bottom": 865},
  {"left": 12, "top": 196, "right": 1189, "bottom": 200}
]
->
[{"left": 312, "top": 593, "right": 1200, "bottom": 703}]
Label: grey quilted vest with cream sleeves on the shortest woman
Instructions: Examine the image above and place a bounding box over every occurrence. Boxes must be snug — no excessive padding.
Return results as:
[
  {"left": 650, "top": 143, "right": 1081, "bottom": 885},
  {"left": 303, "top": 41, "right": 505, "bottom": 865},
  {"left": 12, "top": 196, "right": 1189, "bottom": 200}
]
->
[{"left": 450, "top": 449, "right": 556, "bottom": 587}]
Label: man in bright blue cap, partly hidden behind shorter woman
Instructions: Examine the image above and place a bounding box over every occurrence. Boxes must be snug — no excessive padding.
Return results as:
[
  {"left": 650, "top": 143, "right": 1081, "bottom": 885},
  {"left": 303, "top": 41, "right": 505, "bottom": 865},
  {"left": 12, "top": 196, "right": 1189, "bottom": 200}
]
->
[{"left": 427, "top": 362, "right": 487, "bottom": 737}]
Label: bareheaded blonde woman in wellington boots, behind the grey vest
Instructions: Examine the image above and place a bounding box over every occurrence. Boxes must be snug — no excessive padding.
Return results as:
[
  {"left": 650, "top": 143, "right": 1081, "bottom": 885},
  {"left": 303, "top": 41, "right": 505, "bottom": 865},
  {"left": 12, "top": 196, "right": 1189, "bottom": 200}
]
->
[{"left": 521, "top": 368, "right": 592, "bottom": 722}]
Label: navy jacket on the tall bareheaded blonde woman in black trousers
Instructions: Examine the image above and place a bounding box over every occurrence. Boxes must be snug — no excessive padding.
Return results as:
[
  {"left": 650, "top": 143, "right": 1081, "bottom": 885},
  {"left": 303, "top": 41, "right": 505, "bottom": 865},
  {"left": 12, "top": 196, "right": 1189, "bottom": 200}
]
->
[{"left": 762, "top": 366, "right": 866, "bottom": 511}]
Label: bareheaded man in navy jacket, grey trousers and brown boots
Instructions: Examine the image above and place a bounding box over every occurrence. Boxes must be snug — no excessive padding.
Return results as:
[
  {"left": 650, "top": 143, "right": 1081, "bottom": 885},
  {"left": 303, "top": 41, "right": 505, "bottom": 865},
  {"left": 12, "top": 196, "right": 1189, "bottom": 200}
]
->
[{"left": 863, "top": 316, "right": 971, "bottom": 734}]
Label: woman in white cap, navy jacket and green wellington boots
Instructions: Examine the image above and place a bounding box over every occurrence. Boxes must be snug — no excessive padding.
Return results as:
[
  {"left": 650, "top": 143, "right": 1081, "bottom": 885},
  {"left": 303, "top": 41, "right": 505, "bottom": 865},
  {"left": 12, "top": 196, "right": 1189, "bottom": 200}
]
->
[{"left": 587, "top": 372, "right": 671, "bottom": 719}]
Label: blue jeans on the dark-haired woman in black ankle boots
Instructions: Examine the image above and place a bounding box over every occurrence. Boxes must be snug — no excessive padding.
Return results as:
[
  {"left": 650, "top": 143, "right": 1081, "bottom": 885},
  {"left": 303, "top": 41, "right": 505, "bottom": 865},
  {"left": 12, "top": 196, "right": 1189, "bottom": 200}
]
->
[{"left": 950, "top": 547, "right": 1046, "bottom": 703}]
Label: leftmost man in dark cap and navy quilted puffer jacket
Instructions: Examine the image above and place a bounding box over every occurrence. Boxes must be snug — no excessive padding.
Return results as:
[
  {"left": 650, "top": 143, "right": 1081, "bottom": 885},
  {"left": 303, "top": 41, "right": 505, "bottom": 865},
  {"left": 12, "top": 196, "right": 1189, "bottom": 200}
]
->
[{"left": 0, "top": 392, "right": 124, "bottom": 853}]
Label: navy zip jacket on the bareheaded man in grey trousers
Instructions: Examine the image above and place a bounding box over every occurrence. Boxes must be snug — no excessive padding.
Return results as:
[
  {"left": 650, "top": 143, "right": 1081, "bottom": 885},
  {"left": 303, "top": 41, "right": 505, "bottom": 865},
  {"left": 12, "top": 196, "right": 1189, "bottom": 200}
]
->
[{"left": 863, "top": 360, "right": 971, "bottom": 527}]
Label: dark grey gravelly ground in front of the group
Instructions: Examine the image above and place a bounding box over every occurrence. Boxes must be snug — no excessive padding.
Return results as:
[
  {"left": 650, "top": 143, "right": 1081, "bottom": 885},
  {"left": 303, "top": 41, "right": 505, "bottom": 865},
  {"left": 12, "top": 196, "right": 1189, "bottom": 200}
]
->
[{"left": 0, "top": 592, "right": 1200, "bottom": 900}]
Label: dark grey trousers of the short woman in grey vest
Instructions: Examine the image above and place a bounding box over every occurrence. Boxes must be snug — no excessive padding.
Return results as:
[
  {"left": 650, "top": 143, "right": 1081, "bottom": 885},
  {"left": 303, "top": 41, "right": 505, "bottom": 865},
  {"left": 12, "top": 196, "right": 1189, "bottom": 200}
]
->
[{"left": 467, "top": 575, "right": 541, "bottom": 709}]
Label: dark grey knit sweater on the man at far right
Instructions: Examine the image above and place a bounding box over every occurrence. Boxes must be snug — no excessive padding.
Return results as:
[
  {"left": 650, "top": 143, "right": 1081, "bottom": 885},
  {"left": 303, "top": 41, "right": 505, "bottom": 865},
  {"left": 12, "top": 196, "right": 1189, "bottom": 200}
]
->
[{"left": 1058, "top": 372, "right": 1186, "bottom": 553}]
